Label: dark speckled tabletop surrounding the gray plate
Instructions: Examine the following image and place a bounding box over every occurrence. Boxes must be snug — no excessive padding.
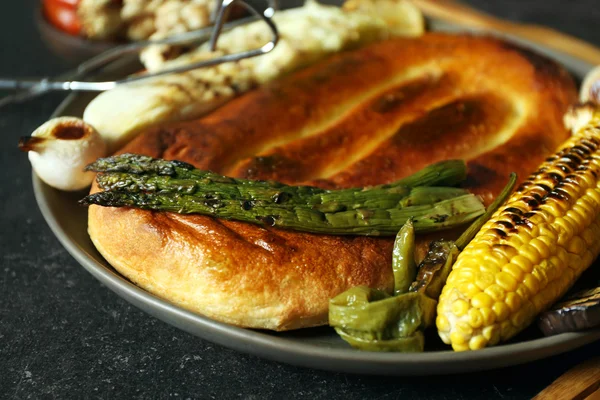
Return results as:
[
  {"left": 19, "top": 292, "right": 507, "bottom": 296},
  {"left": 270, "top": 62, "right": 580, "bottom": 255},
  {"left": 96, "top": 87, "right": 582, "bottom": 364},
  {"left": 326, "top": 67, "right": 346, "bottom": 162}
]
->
[{"left": 0, "top": 0, "right": 600, "bottom": 400}]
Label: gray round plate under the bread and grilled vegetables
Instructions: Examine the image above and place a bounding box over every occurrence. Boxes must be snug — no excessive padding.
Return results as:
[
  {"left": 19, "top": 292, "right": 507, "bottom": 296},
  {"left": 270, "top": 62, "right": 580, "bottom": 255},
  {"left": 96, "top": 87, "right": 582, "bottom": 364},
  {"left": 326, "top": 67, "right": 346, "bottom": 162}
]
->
[{"left": 33, "top": 21, "right": 600, "bottom": 375}]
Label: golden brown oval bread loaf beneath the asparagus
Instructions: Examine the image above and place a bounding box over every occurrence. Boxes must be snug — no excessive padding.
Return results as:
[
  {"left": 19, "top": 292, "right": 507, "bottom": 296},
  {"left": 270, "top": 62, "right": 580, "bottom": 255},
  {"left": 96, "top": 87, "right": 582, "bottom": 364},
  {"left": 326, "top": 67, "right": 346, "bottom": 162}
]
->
[{"left": 89, "top": 34, "right": 577, "bottom": 330}]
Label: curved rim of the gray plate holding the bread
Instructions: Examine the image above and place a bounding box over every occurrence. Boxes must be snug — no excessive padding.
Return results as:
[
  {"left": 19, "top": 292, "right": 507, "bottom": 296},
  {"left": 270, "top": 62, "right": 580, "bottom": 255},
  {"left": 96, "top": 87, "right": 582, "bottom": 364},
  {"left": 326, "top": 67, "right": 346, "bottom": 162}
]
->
[{"left": 32, "top": 23, "right": 600, "bottom": 376}]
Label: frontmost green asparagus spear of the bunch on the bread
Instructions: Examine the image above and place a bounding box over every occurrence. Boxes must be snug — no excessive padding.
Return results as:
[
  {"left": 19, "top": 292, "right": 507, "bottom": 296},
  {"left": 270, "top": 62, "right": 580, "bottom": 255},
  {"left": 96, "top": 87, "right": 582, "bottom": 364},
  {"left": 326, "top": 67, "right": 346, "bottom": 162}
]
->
[{"left": 80, "top": 191, "right": 484, "bottom": 236}]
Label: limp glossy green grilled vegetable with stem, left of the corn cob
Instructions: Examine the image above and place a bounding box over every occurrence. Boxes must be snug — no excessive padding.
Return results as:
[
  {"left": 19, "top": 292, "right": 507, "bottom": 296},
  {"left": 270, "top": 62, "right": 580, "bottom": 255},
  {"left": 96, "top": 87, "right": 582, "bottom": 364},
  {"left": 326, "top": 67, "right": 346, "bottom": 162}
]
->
[{"left": 329, "top": 174, "right": 516, "bottom": 352}]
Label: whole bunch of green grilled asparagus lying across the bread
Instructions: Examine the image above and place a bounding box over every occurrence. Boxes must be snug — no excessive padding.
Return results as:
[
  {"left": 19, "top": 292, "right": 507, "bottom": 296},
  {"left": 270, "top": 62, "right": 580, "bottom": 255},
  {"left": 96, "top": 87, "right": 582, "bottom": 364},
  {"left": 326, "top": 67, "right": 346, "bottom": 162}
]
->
[{"left": 80, "top": 155, "right": 484, "bottom": 235}]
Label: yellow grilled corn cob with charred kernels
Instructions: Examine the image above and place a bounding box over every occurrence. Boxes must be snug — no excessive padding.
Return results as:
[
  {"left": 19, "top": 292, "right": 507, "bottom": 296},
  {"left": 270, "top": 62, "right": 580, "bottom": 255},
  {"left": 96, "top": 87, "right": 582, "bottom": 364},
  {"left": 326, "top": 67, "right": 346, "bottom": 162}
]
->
[{"left": 436, "top": 104, "right": 600, "bottom": 350}]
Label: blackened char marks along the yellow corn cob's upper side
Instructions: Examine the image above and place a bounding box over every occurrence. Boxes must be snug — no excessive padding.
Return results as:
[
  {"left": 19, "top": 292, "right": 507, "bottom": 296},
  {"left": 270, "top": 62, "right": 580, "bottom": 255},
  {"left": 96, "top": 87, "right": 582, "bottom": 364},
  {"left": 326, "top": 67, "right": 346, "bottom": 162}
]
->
[{"left": 494, "top": 138, "right": 600, "bottom": 239}]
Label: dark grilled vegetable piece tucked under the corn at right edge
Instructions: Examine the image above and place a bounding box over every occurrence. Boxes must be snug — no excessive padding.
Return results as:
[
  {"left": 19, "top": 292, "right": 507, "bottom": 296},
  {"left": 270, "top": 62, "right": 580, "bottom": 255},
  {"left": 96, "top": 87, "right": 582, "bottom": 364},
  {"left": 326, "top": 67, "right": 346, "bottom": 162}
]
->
[{"left": 538, "top": 287, "right": 600, "bottom": 336}]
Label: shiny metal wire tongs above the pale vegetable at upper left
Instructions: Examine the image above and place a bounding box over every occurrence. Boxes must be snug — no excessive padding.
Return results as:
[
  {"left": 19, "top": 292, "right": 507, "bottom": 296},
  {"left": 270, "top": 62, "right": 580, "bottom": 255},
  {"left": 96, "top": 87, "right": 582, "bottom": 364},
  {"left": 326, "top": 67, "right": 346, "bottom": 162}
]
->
[{"left": 0, "top": 0, "right": 279, "bottom": 107}]
